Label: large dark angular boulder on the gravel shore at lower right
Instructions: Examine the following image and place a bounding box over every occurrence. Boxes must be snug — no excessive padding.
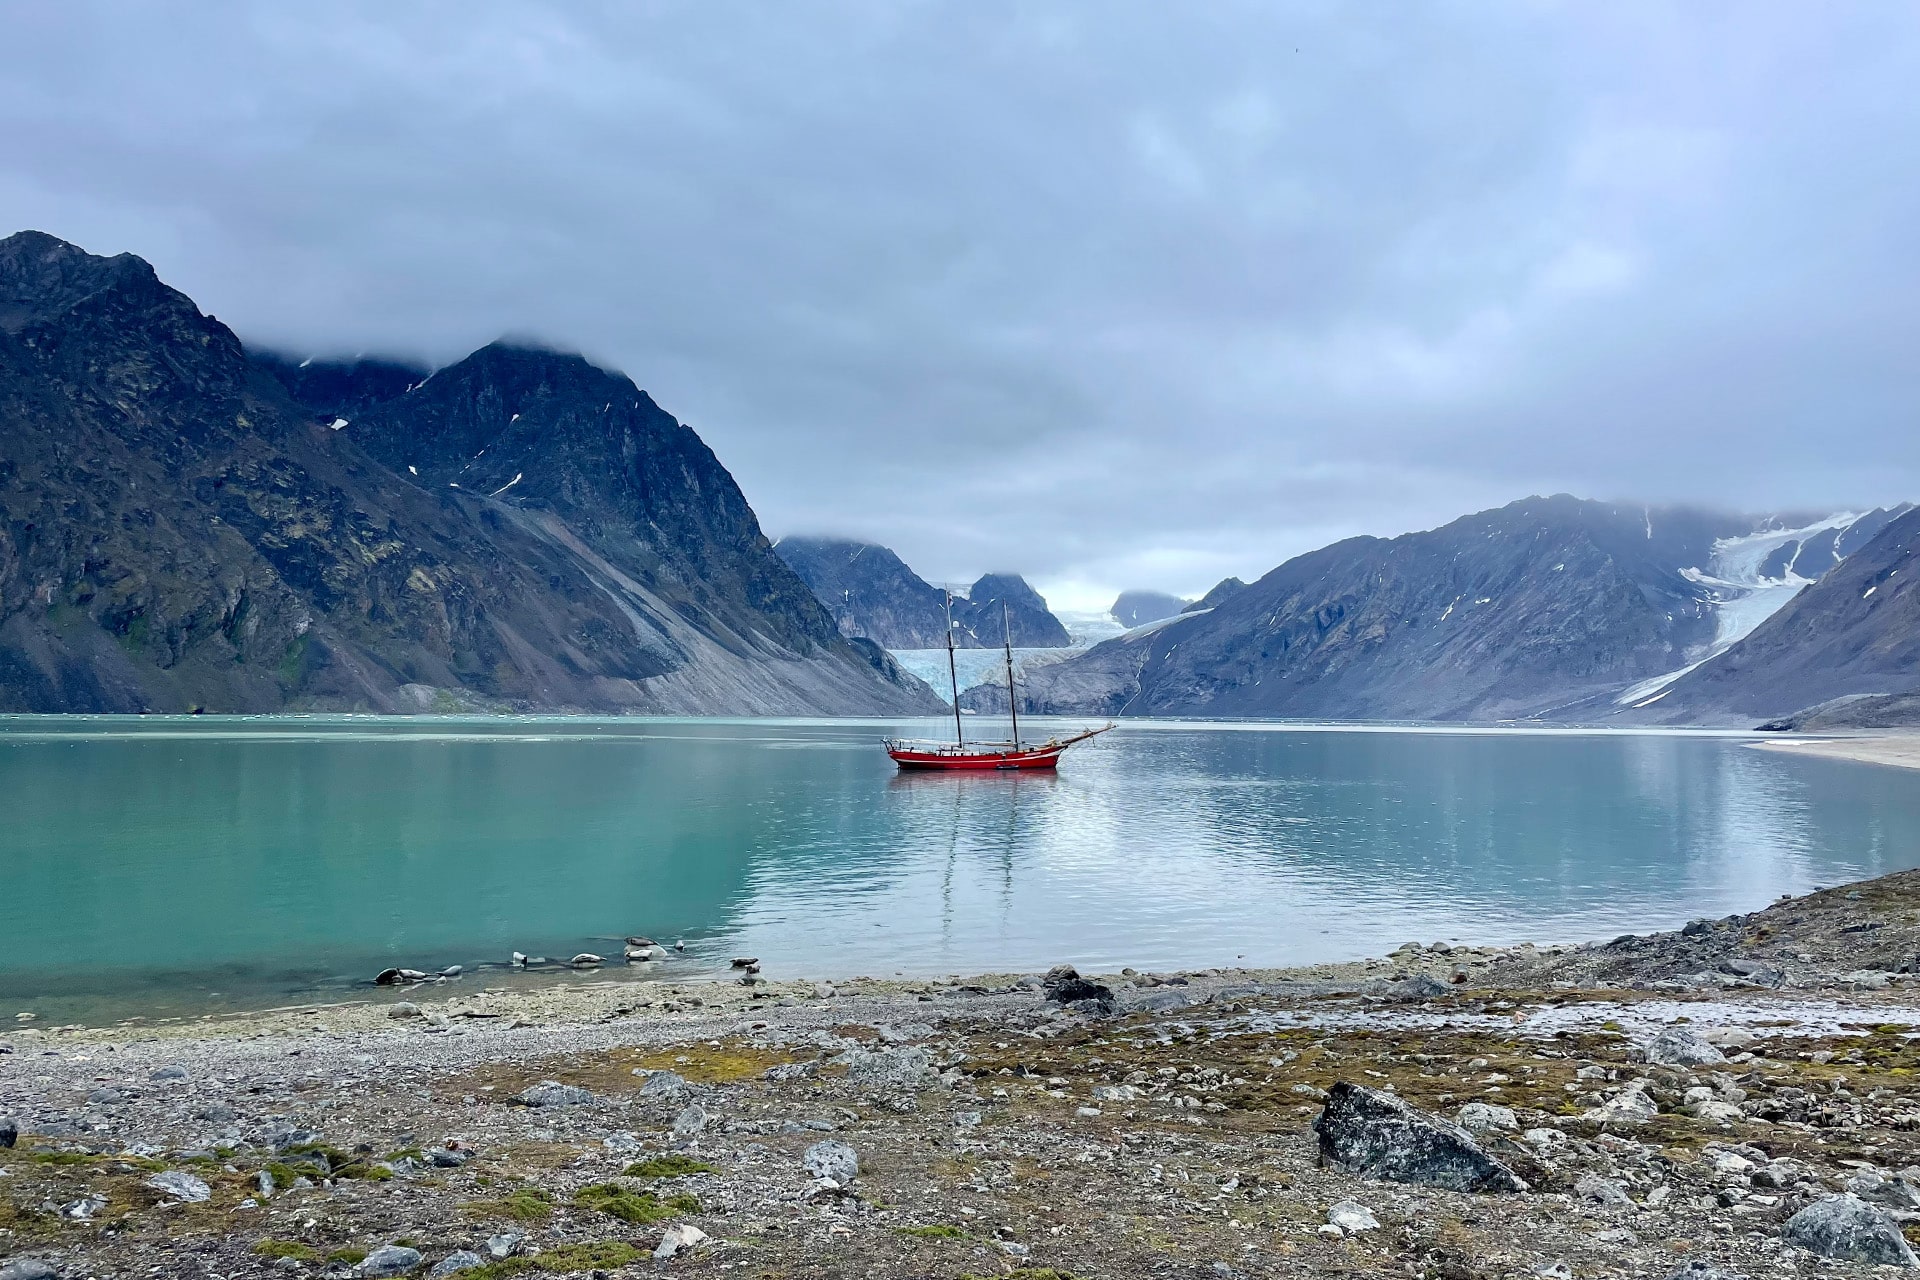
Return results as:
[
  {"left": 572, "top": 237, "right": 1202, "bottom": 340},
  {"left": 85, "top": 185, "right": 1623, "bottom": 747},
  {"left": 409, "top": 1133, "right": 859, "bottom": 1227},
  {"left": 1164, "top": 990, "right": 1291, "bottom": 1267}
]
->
[{"left": 1313, "top": 1080, "right": 1526, "bottom": 1192}]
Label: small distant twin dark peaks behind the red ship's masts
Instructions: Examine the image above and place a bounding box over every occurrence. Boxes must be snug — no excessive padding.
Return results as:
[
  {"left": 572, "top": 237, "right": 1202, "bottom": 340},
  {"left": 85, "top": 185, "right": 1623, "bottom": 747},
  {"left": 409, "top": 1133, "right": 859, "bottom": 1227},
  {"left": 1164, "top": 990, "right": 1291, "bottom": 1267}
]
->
[{"left": 774, "top": 537, "right": 1073, "bottom": 649}]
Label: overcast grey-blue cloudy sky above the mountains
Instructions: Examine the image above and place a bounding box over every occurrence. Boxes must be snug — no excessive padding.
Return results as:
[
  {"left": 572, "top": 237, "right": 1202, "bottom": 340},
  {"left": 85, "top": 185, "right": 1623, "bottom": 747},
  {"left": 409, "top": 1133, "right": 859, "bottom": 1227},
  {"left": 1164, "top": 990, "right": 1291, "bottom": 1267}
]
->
[{"left": 0, "top": 0, "right": 1920, "bottom": 608}]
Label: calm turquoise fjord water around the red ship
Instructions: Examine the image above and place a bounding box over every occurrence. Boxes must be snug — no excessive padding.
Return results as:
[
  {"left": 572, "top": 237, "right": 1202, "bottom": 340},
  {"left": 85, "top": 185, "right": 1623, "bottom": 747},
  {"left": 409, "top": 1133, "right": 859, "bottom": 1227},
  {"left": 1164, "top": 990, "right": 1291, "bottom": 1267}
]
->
[{"left": 0, "top": 718, "right": 1920, "bottom": 1019}]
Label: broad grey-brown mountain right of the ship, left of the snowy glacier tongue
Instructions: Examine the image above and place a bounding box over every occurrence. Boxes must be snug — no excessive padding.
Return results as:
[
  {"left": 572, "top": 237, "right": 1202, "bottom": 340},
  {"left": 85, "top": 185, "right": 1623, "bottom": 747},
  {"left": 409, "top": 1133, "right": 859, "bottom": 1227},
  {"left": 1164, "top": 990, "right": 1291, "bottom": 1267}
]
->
[{"left": 990, "top": 495, "right": 1753, "bottom": 720}]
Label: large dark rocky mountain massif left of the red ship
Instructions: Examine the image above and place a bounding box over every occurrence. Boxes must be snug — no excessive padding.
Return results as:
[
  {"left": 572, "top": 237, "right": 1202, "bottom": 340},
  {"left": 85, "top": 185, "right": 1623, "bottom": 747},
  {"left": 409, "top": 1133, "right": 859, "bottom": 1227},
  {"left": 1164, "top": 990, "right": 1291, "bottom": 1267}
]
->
[{"left": 0, "top": 232, "right": 939, "bottom": 714}]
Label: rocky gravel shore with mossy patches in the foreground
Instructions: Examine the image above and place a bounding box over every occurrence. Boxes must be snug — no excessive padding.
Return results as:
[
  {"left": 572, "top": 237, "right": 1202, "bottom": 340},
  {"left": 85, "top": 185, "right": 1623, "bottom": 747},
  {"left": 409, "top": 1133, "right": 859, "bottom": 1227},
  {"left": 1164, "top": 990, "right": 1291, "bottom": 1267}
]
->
[{"left": 0, "top": 873, "right": 1920, "bottom": 1280}]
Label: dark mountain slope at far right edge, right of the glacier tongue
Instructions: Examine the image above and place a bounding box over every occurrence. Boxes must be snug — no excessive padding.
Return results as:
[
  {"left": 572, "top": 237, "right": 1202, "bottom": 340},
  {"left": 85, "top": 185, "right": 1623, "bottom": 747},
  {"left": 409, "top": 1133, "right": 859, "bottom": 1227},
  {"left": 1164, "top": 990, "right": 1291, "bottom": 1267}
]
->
[{"left": 1640, "top": 509, "right": 1920, "bottom": 729}]
